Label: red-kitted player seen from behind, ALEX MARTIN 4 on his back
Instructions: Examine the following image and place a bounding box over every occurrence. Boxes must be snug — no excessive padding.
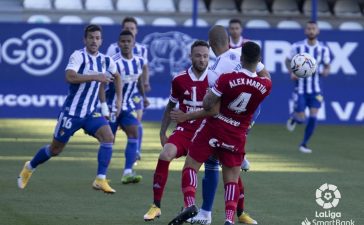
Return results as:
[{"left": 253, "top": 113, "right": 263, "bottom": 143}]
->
[{"left": 169, "top": 42, "right": 272, "bottom": 225}]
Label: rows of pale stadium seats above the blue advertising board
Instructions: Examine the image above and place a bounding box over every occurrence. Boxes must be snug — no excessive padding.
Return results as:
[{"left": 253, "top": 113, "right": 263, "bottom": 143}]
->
[{"left": 0, "top": 0, "right": 364, "bottom": 29}]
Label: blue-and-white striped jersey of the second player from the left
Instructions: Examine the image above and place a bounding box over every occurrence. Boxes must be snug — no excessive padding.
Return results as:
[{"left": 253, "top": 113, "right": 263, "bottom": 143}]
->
[{"left": 106, "top": 52, "right": 144, "bottom": 111}]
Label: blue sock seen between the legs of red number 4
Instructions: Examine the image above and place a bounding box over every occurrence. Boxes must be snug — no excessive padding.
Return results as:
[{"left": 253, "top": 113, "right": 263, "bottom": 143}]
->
[{"left": 201, "top": 157, "right": 219, "bottom": 212}]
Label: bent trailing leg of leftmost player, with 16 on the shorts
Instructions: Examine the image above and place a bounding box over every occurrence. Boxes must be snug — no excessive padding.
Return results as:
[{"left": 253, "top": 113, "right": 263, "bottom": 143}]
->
[{"left": 18, "top": 113, "right": 77, "bottom": 189}]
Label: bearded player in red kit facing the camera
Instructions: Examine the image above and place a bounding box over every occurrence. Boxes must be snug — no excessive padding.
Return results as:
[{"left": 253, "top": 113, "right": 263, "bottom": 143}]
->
[{"left": 144, "top": 40, "right": 209, "bottom": 221}]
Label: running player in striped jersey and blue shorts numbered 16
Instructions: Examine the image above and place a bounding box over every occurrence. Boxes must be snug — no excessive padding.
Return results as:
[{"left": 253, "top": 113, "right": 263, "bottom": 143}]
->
[{"left": 18, "top": 25, "right": 121, "bottom": 193}]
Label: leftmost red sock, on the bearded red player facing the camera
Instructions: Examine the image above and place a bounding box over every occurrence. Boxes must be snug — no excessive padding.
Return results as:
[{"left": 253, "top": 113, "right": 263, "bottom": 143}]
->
[{"left": 153, "top": 159, "right": 170, "bottom": 208}]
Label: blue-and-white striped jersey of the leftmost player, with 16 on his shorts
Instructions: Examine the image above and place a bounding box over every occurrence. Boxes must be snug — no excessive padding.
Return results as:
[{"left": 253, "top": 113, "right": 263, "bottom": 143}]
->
[{"left": 62, "top": 48, "right": 116, "bottom": 118}]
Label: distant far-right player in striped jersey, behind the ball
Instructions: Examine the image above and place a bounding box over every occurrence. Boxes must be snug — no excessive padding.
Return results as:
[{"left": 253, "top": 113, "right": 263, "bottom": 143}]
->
[{"left": 286, "top": 21, "right": 330, "bottom": 153}]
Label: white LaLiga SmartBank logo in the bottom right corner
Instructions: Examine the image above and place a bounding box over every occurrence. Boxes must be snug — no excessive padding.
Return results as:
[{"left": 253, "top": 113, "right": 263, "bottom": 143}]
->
[{"left": 301, "top": 183, "right": 355, "bottom": 225}]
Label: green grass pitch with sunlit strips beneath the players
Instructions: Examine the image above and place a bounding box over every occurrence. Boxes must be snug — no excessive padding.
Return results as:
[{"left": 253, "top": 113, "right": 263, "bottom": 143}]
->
[{"left": 0, "top": 120, "right": 364, "bottom": 225}]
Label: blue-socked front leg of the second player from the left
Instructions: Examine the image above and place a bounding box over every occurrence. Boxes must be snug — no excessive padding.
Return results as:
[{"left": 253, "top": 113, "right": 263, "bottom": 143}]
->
[{"left": 121, "top": 112, "right": 142, "bottom": 184}]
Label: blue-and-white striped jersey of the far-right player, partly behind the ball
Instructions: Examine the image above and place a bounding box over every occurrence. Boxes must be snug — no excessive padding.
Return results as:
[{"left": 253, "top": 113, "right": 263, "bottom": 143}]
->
[{"left": 287, "top": 39, "right": 331, "bottom": 94}]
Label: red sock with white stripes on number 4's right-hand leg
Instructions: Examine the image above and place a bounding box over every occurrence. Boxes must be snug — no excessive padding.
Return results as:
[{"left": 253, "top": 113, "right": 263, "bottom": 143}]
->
[{"left": 225, "top": 182, "right": 239, "bottom": 223}]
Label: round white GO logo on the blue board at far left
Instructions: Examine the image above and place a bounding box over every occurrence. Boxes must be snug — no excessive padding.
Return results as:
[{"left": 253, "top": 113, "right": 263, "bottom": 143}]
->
[{"left": 0, "top": 28, "right": 63, "bottom": 76}]
